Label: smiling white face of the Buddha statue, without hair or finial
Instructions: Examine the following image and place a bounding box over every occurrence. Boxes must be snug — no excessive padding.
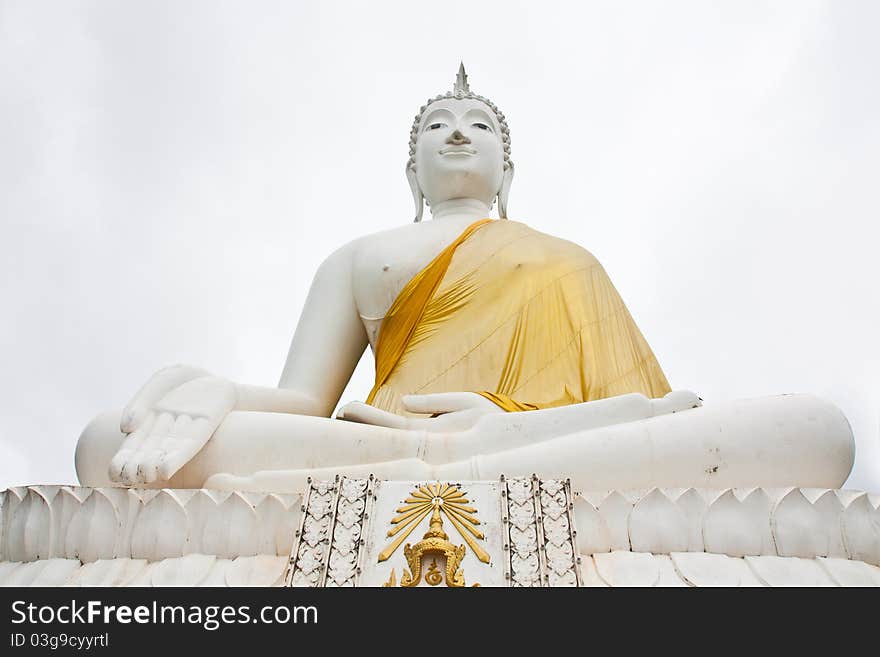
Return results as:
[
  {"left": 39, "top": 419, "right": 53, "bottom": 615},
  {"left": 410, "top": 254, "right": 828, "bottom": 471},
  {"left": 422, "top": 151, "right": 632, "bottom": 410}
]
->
[{"left": 415, "top": 98, "right": 504, "bottom": 205}]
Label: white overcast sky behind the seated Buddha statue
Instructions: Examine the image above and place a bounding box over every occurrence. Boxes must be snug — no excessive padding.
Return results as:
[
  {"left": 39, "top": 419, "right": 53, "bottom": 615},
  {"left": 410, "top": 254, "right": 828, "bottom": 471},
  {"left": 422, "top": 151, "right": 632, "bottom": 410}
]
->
[{"left": 0, "top": 0, "right": 880, "bottom": 491}]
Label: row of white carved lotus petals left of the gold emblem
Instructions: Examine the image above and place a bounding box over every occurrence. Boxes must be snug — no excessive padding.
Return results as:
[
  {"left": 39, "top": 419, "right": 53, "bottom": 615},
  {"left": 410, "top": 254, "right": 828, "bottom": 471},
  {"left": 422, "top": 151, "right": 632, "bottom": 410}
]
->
[{"left": 0, "top": 486, "right": 301, "bottom": 563}]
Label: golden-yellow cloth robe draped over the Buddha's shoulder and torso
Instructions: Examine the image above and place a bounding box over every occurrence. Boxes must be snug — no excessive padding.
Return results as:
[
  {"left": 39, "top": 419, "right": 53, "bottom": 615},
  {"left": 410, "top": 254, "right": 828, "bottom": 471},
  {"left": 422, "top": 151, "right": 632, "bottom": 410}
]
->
[{"left": 367, "top": 219, "right": 670, "bottom": 415}]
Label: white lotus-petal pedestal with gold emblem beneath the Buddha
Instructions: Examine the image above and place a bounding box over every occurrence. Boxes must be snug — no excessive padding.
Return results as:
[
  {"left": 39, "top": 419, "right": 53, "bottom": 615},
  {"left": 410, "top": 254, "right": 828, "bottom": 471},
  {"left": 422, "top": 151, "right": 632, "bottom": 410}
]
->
[{"left": 0, "top": 478, "right": 880, "bottom": 587}]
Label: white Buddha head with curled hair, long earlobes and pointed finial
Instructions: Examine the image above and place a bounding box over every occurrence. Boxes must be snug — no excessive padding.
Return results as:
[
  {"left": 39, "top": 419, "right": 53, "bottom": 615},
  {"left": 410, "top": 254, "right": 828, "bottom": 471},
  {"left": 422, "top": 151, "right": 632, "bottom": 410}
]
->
[{"left": 406, "top": 65, "right": 513, "bottom": 221}]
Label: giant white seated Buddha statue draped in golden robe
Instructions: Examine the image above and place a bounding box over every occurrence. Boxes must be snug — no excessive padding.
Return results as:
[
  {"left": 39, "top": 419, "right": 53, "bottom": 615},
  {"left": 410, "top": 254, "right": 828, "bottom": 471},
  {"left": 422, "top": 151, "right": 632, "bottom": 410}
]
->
[{"left": 76, "top": 67, "right": 854, "bottom": 491}]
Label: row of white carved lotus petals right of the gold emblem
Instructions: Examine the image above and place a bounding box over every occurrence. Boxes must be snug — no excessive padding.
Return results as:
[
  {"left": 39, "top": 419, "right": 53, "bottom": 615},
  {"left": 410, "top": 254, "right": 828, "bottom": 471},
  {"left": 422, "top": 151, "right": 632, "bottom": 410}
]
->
[{"left": 574, "top": 488, "right": 880, "bottom": 565}]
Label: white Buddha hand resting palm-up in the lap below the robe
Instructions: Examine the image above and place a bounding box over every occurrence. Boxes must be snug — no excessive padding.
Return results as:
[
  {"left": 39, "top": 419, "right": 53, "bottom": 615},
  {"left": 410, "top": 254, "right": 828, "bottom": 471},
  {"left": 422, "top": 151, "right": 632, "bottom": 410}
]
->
[{"left": 336, "top": 392, "right": 504, "bottom": 432}]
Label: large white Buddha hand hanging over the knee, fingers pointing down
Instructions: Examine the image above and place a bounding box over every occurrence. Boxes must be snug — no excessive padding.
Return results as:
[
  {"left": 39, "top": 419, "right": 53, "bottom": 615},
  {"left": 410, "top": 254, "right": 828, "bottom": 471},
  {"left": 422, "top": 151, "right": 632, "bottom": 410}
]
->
[{"left": 109, "top": 365, "right": 236, "bottom": 486}]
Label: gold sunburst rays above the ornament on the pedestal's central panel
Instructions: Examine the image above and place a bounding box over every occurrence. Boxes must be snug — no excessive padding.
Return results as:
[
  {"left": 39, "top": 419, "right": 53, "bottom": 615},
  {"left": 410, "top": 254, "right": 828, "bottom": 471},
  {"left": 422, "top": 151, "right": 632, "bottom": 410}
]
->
[{"left": 379, "top": 482, "right": 490, "bottom": 563}]
